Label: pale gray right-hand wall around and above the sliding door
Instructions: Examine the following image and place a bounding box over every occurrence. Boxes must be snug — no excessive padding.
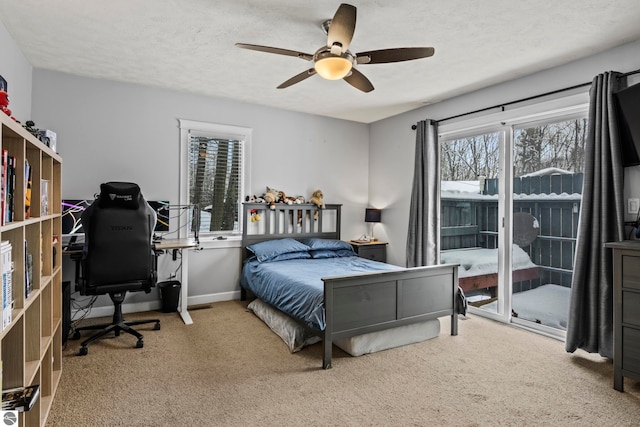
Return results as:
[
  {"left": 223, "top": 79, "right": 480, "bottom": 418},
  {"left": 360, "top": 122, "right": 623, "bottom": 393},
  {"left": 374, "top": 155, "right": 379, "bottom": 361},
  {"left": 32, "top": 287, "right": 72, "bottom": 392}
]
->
[{"left": 369, "top": 41, "right": 640, "bottom": 266}]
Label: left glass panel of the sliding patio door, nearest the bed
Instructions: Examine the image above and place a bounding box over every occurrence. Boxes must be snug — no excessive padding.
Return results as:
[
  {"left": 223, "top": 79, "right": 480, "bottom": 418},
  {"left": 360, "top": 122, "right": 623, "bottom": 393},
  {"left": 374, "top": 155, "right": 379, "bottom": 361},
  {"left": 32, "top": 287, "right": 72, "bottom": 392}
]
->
[{"left": 440, "top": 129, "right": 508, "bottom": 319}]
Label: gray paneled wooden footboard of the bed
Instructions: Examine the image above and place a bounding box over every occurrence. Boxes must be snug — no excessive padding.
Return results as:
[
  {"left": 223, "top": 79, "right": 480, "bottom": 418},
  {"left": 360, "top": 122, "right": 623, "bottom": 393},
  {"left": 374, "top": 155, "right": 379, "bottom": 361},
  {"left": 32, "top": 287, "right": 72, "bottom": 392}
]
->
[{"left": 322, "top": 264, "right": 458, "bottom": 369}]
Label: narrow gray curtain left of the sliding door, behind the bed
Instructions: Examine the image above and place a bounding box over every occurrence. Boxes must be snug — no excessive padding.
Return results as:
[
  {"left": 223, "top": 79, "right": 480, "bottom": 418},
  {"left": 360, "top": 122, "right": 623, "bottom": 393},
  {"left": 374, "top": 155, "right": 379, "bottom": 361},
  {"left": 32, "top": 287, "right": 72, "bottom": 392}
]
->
[{"left": 407, "top": 120, "right": 440, "bottom": 267}]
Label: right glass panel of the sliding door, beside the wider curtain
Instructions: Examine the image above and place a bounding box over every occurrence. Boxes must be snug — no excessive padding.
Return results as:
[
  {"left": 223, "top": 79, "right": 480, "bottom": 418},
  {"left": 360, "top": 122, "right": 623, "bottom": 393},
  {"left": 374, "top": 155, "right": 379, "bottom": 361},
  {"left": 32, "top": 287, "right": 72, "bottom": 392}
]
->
[{"left": 511, "top": 117, "right": 587, "bottom": 332}]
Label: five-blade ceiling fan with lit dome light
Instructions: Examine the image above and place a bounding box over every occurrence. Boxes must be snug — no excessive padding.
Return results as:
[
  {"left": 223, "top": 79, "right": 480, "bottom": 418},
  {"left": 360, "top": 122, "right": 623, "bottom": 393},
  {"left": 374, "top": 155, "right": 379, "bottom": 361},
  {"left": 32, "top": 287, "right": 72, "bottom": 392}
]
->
[{"left": 236, "top": 3, "right": 435, "bottom": 92}]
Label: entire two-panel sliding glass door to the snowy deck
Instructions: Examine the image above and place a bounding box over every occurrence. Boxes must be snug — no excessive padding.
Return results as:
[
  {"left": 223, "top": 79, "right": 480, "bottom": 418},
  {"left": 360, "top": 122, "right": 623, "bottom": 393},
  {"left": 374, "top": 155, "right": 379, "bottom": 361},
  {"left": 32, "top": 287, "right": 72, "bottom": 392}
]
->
[{"left": 440, "top": 117, "right": 586, "bottom": 336}]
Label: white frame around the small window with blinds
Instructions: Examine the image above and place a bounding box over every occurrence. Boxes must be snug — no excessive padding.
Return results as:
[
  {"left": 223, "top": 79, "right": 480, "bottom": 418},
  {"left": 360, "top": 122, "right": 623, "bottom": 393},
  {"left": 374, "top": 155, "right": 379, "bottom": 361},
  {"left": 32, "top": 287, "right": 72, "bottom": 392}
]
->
[{"left": 178, "top": 119, "right": 253, "bottom": 244}]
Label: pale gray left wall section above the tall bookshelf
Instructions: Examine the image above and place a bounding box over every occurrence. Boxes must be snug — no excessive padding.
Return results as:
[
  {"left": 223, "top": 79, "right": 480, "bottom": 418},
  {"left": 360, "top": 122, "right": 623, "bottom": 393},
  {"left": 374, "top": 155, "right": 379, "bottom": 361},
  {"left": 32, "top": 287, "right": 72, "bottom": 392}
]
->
[{"left": 0, "top": 22, "right": 33, "bottom": 123}]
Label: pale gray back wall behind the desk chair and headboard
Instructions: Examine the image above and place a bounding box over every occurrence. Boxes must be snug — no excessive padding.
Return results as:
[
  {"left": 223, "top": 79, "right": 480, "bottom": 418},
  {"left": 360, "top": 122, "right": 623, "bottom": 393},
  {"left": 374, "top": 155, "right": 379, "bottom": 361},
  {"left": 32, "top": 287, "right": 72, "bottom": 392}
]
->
[{"left": 33, "top": 69, "right": 369, "bottom": 310}]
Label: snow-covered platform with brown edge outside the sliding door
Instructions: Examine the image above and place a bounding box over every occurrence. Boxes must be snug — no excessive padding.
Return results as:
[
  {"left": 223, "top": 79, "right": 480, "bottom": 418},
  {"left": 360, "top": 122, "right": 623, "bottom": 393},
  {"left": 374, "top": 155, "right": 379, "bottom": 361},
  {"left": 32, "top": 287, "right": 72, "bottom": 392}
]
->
[{"left": 440, "top": 243, "right": 539, "bottom": 292}]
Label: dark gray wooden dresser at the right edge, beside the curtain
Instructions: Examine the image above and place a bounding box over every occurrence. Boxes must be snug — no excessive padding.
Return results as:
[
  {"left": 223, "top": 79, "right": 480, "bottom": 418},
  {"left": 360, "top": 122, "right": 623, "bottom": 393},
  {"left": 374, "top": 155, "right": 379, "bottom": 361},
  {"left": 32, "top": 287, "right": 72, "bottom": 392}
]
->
[{"left": 605, "top": 240, "right": 640, "bottom": 391}]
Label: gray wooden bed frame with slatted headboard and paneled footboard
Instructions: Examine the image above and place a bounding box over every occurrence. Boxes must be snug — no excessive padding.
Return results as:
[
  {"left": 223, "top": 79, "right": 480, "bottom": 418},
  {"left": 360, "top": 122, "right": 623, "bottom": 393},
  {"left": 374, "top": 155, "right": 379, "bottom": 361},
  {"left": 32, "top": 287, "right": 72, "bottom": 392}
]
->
[{"left": 241, "top": 203, "right": 458, "bottom": 369}]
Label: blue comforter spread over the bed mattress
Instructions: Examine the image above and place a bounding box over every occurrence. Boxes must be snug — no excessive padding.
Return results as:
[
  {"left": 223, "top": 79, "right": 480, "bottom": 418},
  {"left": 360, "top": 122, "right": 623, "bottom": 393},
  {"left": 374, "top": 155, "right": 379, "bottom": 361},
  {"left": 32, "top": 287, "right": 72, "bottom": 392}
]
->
[{"left": 240, "top": 256, "right": 400, "bottom": 330}]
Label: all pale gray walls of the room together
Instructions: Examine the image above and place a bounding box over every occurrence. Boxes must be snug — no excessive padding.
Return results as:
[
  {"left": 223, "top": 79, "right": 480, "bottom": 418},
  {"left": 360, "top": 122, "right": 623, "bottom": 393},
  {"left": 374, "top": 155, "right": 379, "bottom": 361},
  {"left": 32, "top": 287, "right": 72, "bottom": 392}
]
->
[{"left": 5, "top": 12, "right": 640, "bottom": 310}]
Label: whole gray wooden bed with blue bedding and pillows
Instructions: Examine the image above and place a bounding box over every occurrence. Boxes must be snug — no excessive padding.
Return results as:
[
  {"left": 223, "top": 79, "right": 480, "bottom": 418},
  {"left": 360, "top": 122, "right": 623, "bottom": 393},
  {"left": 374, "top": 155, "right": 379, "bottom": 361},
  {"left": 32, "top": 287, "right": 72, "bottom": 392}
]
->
[{"left": 240, "top": 203, "right": 459, "bottom": 369}]
